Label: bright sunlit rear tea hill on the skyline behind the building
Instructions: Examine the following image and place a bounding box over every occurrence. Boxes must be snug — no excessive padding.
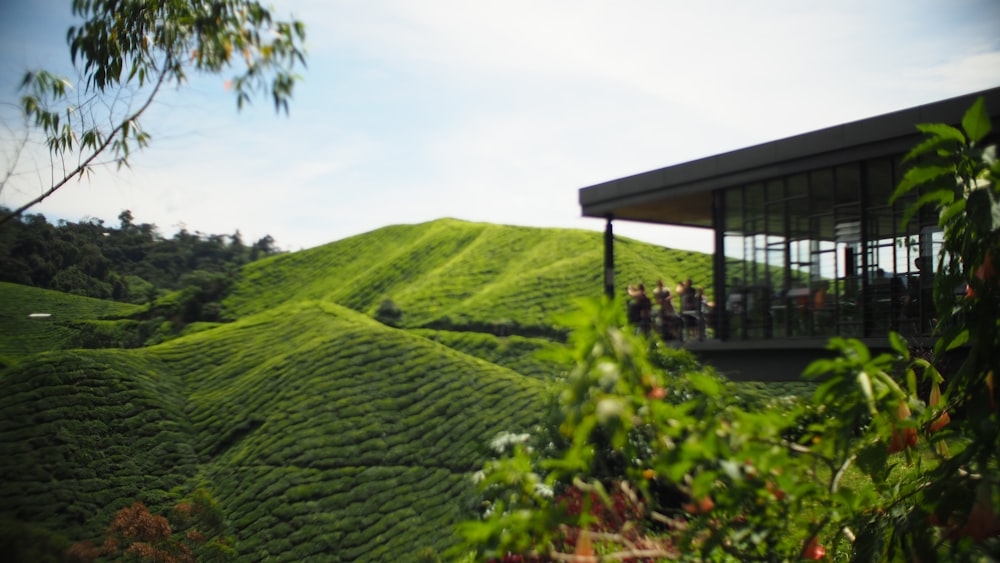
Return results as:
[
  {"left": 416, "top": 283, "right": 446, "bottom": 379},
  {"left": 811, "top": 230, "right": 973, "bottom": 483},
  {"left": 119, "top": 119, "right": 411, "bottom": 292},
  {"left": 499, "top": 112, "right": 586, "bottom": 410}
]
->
[{"left": 226, "top": 219, "right": 711, "bottom": 332}]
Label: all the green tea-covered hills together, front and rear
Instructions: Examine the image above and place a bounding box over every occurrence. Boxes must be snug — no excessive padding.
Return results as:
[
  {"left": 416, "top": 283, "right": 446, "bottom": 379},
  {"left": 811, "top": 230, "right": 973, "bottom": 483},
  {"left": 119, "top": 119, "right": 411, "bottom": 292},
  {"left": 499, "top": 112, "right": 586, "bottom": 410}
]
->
[{"left": 0, "top": 220, "right": 709, "bottom": 561}]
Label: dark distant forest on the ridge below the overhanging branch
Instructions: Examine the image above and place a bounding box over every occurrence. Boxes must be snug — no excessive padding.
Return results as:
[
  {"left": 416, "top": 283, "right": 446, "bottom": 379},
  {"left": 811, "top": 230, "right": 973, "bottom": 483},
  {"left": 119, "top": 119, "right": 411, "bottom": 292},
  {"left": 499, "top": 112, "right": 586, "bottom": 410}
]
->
[{"left": 0, "top": 208, "right": 281, "bottom": 304}]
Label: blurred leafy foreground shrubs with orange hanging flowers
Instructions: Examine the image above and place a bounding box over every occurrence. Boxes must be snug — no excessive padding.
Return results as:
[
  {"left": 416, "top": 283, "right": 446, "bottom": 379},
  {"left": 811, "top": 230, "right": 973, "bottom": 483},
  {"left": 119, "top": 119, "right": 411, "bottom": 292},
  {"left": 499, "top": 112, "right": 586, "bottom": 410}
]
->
[{"left": 455, "top": 102, "right": 1000, "bottom": 562}]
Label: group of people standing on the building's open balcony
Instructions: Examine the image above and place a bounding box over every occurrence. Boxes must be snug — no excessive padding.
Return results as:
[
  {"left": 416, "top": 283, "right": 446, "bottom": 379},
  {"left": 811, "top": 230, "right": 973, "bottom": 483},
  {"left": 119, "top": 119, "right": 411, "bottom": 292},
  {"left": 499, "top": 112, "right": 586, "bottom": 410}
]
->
[{"left": 628, "top": 278, "right": 711, "bottom": 340}]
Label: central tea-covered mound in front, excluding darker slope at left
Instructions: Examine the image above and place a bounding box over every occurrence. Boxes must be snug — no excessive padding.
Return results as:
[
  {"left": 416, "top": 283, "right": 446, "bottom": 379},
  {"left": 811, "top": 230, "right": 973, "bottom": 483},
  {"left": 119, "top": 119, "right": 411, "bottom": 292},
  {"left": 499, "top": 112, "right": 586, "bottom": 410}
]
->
[{"left": 156, "top": 302, "right": 541, "bottom": 561}]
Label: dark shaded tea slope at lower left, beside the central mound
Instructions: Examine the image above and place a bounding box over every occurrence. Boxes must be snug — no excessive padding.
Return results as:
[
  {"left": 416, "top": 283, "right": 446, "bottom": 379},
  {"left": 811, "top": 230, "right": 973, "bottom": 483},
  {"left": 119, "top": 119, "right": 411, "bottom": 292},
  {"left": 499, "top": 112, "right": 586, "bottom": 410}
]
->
[{"left": 0, "top": 350, "right": 196, "bottom": 538}]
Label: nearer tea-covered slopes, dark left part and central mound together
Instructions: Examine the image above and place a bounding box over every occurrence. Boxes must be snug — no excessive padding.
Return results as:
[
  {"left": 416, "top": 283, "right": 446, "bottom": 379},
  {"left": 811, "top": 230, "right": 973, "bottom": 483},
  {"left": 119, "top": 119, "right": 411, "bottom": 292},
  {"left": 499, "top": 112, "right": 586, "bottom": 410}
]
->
[{"left": 0, "top": 302, "right": 542, "bottom": 561}]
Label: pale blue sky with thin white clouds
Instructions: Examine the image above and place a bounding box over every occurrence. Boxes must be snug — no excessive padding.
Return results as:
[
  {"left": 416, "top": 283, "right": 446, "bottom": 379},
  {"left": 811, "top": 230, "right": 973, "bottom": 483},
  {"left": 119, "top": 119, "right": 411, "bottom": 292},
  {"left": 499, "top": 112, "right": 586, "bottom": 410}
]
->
[{"left": 0, "top": 0, "right": 1000, "bottom": 252}]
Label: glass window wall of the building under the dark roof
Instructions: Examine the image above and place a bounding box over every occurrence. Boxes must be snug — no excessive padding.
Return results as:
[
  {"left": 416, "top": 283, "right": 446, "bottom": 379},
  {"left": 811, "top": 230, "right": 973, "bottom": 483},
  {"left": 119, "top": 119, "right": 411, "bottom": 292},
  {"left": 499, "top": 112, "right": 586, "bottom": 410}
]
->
[{"left": 722, "top": 155, "right": 941, "bottom": 339}]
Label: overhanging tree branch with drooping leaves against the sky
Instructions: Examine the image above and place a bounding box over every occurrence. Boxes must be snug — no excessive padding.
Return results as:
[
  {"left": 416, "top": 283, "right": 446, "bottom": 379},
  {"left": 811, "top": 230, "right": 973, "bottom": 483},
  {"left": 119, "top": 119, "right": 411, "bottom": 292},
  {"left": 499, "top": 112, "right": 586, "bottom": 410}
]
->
[{"left": 0, "top": 0, "right": 305, "bottom": 224}]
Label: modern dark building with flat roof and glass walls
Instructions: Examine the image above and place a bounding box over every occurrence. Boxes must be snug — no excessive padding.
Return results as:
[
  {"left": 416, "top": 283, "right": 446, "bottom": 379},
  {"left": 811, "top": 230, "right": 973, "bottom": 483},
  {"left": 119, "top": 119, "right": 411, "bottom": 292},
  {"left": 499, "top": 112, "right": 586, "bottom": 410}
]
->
[{"left": 580, "top": 88, "right": 1000, "bottom": 379}]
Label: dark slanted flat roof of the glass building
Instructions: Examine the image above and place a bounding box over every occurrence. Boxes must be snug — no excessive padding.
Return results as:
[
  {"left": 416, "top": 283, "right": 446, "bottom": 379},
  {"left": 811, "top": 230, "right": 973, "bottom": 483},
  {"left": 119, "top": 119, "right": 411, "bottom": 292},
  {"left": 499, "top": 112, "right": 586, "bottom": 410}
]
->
[{"left": 580, "top": 87, "right": 1000, "bottom": 227}]
